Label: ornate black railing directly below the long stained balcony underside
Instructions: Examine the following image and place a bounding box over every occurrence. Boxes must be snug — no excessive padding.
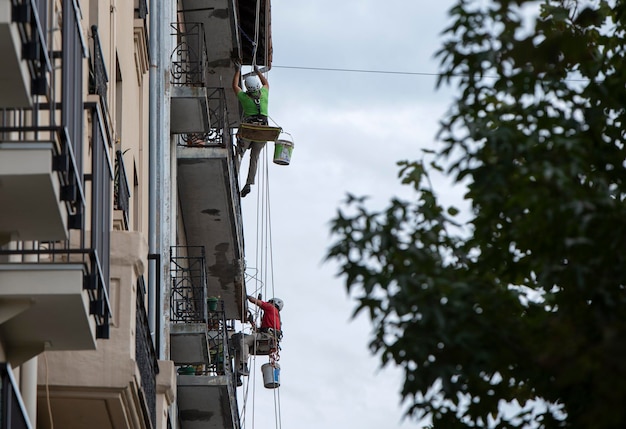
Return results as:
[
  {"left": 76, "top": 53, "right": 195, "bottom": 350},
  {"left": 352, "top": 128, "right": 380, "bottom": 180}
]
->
[{"left": 170, "top": 246, "right": 207, "bottom": 323}]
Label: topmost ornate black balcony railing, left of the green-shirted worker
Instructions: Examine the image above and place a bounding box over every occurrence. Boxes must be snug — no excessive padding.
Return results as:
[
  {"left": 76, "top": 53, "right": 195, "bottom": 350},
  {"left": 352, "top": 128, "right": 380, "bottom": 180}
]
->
[{"left": 171, "top": 22, "right": 208, "bottom": 86}]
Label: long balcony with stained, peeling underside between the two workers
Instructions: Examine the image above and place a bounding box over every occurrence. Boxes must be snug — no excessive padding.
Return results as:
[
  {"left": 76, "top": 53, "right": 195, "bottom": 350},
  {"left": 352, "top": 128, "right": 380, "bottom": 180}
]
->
[{"left": 176, "top": 128, "right": 246, "bottom": 319}]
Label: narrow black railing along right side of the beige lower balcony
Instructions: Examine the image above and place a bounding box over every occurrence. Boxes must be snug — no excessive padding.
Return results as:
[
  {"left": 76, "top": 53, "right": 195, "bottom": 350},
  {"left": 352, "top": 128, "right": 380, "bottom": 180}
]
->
[{"left": 135, "top": 276, "right": 159, "bottom": 427}]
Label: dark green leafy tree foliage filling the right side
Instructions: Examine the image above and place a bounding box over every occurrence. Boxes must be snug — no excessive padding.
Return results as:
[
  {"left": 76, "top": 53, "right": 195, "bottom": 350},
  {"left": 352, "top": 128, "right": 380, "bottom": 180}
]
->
[{"left": 328, "top": 0, "right": 626, "bottom": 429}]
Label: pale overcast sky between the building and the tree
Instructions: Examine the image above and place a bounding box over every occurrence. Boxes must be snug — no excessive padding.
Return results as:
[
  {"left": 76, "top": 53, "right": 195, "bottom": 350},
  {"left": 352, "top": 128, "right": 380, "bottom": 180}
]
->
[{"left": 238, "top": 0, "right": 461, "bottom": 429}]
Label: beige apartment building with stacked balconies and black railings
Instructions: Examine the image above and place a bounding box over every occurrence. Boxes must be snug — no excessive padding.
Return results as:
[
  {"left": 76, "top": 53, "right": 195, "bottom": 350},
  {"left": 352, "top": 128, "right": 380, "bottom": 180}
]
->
[{"left": 0, "top": 0, "right": 272, "bottom": 429}]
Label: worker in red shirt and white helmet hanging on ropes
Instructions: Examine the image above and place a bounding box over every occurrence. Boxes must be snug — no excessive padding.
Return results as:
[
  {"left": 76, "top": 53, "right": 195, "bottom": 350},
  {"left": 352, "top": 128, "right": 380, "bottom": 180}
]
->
[{"left": 233, "top": 296, "right": 283, "bottom": 384}]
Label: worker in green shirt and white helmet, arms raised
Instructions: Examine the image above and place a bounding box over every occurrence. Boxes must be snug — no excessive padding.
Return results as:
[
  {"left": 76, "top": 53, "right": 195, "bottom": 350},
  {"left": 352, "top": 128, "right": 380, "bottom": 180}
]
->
[{"left": 233, "top": 62, "right": 270, "bottom": 197}]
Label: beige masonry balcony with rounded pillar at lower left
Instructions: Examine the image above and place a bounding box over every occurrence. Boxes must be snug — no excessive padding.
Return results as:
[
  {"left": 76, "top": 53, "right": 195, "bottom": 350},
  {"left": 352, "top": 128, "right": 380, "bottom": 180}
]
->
[{"left": 37, "top": 231, "right": 168, "bottom": 429}]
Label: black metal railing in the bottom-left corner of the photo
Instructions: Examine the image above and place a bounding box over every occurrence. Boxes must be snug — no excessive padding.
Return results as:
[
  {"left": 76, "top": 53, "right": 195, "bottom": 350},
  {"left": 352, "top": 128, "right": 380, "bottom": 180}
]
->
[{"left": 0, "top": 362, "right": 31, "bottom": 429}]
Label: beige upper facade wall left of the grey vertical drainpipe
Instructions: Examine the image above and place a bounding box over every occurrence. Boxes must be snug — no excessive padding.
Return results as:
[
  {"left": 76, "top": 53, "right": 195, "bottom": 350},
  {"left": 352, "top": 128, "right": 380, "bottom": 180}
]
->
[{"left": 80, "top": 0, "right": 149, "bottom": 234}]
